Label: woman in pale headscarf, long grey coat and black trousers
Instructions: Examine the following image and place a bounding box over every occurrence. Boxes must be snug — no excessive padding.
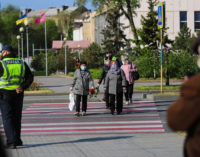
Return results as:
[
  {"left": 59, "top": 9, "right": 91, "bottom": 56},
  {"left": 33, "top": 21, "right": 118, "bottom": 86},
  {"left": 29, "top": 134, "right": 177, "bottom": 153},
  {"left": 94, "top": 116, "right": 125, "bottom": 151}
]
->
[{"left": 104, "top": 61, "right": 126, "bottom": 115}]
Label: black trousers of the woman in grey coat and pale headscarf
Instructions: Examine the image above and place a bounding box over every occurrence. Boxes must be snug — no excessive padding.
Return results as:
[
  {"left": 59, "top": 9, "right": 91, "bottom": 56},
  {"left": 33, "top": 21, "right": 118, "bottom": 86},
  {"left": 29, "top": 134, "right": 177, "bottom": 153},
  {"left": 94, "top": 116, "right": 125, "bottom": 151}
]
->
[{"left": 109, "top": 93, "right": 123, "bottom": 113}]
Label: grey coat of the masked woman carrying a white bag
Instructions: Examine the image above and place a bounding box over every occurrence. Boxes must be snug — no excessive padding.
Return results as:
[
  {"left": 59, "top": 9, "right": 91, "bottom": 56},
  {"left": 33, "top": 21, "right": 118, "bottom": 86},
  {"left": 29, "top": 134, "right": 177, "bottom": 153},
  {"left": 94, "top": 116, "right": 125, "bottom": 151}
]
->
[{"left": 72, "top": 69, "right": 94, "bottom": 95}]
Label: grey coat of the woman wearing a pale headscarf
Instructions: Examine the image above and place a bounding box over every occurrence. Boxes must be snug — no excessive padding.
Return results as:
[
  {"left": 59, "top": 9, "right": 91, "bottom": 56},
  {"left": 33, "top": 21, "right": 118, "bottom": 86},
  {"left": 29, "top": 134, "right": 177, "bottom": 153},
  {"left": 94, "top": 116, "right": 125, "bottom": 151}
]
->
[{"left": 104, "top": 70, "right": 126, "bottom": 95}]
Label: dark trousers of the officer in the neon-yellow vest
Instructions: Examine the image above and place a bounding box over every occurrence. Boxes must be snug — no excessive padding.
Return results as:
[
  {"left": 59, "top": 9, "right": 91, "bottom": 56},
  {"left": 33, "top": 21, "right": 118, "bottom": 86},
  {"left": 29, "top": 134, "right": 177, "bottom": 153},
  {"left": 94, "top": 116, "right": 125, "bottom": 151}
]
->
[{"left": 0, "top": 94, "right": 24, "bottom": 144}]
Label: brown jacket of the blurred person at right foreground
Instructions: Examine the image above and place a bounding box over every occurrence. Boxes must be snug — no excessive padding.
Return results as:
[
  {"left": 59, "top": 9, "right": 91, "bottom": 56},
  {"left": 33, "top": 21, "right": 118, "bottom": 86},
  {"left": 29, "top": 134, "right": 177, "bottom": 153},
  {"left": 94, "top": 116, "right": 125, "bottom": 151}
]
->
[{"left": 167, "top": 74, "right": 200, "bottom": 157}]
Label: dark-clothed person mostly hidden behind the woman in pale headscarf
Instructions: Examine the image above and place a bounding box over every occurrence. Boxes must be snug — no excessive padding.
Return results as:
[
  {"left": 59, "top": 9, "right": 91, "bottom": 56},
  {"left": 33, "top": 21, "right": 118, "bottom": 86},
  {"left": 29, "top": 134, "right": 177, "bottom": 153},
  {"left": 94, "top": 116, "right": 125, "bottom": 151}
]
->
[{"left": 97, "top": 57, "right": 111, "bottom": 108}]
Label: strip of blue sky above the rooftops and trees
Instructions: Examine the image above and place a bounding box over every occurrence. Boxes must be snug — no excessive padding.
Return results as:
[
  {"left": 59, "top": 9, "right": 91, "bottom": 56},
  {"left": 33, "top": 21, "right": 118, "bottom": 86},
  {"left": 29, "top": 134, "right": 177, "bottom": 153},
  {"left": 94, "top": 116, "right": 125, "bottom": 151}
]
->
[{"left": 0, "top": 0, "right": 94, "bottom": 10}]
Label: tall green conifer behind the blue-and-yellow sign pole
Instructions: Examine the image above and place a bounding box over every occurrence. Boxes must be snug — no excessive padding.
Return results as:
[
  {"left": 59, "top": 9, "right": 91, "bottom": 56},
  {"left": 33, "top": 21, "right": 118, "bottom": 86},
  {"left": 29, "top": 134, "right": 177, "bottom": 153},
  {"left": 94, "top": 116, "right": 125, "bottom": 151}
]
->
[{"left": 135, "top": 0, "right": 172, "bottom": 85}]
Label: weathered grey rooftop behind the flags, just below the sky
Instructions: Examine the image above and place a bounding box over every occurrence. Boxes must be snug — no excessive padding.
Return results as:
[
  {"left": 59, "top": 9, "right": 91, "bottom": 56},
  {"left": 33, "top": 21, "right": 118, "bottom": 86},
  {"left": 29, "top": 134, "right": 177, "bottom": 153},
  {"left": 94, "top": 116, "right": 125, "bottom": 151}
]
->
[{"left": 28, "top": 7, "right": 77, "bottom": 17}]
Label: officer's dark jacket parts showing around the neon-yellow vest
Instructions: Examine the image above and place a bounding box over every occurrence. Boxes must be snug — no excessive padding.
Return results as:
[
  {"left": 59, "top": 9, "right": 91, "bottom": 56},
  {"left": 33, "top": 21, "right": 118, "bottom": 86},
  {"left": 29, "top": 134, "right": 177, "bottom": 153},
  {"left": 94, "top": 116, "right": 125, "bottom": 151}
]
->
[{"left": 0, "top": 55, "right": 33, "bottom": 94}]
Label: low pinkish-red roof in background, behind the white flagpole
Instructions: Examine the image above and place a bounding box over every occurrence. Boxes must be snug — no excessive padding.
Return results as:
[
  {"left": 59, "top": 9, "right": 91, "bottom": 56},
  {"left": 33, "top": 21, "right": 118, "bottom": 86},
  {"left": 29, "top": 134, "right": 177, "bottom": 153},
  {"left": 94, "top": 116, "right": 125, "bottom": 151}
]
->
[{"left": 52, "top": 40, "right": 91, "bottom": 50}]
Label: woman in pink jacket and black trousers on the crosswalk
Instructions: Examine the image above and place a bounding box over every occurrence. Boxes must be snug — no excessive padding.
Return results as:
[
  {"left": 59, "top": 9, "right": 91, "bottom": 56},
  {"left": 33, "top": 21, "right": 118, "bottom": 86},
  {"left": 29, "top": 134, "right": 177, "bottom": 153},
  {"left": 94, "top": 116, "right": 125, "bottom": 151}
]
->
[{"left": 121, "top": 56, "right": 138, "bottom": 105}]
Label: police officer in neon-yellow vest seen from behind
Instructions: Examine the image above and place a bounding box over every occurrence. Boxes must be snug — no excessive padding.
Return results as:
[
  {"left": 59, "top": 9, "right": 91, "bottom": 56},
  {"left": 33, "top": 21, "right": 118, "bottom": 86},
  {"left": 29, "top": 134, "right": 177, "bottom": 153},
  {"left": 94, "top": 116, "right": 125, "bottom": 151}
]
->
[{"left": 0, "top": 45, "right": 33, "bottom": 149}]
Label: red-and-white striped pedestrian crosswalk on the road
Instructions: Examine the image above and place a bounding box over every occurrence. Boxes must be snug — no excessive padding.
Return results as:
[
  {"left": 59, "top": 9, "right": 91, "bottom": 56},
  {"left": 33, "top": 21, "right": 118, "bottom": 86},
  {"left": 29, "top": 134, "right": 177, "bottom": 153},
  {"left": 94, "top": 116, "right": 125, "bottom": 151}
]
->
[{"left": 0, "top": 101, "right": 165, "bottom": 136}]
